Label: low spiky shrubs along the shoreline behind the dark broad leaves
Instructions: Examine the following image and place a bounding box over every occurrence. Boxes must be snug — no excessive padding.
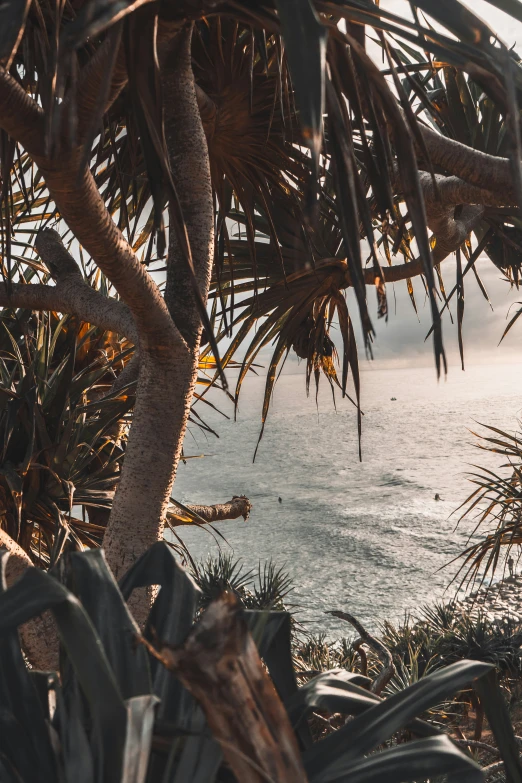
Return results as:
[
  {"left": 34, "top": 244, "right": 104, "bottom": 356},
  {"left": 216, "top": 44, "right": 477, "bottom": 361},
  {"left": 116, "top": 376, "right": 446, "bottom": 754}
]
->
[{"left": 199, "top": 552, "right": 522, "bottom": 734}]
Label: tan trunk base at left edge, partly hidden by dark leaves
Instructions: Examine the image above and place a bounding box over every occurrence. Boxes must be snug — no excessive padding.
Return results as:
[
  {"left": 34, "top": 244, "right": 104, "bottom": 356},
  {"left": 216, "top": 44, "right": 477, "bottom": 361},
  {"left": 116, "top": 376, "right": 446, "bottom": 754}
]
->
[{"left": 0, "top": 528, "right": 58, "bottom": 671}]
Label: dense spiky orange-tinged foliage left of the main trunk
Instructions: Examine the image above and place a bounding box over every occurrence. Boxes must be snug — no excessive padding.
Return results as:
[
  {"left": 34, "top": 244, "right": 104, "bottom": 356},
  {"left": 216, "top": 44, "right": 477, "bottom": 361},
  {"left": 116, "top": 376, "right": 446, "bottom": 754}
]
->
[{"left": 0, "top": 310, "right": 134, "bottom": 565}]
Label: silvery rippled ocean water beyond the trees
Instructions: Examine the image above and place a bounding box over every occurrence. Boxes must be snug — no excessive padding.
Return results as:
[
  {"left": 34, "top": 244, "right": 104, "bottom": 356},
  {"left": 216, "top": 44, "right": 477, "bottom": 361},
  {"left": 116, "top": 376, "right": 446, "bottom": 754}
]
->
[{"left": 174, "top": 364, "right": 522, "bottom": 636}]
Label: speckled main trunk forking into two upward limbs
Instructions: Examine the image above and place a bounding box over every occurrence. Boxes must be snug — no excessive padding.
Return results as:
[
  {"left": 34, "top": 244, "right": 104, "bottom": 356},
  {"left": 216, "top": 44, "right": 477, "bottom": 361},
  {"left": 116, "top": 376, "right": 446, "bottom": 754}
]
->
[{"left": 0, "top": 26, "right": 214, "bottom": 648}]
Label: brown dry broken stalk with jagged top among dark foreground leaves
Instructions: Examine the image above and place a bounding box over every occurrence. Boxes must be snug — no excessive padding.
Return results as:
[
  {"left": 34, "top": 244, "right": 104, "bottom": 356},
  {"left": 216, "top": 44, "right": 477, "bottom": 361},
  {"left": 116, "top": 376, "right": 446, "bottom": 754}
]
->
[{"left": 140, "top": 593, "right": 307, "bottom": 783}]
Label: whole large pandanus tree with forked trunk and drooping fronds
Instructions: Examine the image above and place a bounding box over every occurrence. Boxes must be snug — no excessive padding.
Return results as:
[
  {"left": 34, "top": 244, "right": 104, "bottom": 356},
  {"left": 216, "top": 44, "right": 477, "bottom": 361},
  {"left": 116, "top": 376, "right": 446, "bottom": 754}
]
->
[{"left": 0, "top": 0, "right": 522, "bottom": 665}]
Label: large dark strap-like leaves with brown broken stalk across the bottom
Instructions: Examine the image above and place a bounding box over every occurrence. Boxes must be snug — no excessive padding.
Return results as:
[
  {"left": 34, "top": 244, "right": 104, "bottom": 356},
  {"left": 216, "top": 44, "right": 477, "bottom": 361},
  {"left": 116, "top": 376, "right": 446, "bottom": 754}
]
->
[{"left": 0, "top": 543, "right": 522, "bottom": 783}]
